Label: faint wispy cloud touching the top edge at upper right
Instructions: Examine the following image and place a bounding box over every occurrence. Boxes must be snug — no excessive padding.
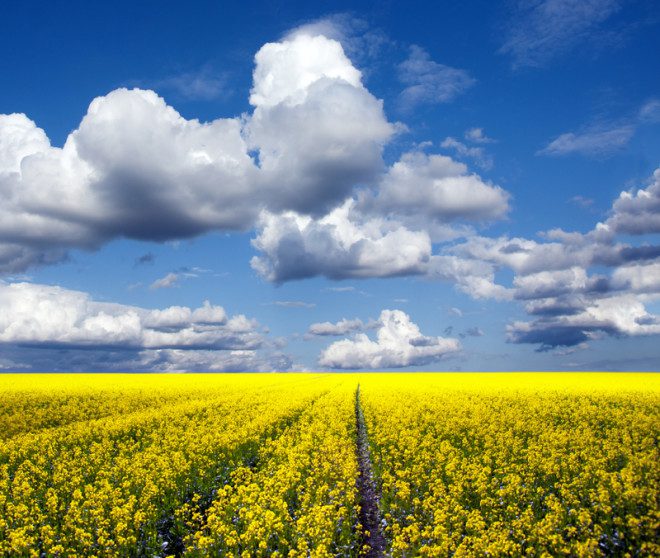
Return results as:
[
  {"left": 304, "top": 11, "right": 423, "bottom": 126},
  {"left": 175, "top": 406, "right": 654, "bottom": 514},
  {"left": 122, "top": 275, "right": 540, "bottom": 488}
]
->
[{"left": 499, "top": 0, "right": 622, "bottom": 68}]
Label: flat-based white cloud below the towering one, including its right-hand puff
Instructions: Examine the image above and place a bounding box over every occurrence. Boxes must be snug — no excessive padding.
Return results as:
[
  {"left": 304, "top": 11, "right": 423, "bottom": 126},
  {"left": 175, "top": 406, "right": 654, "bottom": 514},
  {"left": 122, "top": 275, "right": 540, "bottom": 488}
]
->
[{"left": 252, "top": 152, "right": 509, "bottom": 284}]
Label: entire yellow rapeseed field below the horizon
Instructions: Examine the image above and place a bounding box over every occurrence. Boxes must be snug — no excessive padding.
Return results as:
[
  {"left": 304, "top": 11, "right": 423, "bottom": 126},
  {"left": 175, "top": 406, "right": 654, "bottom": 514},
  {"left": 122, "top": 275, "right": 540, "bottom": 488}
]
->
[{"left": 0, "top": 373, "right": 660, "bottom": 556}]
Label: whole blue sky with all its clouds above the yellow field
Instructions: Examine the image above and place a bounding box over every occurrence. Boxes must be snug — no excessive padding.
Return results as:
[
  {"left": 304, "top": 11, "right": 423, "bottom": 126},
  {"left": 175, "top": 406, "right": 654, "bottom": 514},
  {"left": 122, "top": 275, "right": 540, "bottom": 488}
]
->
[{"left": 0, "top": 0, "right": 660, "bottom": 371}]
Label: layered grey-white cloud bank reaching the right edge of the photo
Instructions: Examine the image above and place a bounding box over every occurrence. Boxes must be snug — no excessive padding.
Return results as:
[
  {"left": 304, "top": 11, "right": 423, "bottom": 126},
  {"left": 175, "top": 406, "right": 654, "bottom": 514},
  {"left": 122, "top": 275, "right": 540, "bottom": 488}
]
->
[{"left": 408, "top": 170, "right": 660, "bottom": 350}]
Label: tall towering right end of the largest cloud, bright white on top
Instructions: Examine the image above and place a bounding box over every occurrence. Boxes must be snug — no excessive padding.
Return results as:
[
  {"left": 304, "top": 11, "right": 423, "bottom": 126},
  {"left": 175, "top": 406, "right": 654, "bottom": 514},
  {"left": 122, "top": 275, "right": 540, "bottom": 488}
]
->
[{"left": 245, "top": 34, "right": 395, "bottom": 215}]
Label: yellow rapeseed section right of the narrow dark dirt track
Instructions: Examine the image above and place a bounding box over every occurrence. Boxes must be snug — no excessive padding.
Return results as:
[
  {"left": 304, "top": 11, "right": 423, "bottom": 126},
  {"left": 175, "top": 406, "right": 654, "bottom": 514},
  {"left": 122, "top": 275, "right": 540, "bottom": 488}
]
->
[{"left": 361, "top": 373, "right": 660, "bottom": 556}]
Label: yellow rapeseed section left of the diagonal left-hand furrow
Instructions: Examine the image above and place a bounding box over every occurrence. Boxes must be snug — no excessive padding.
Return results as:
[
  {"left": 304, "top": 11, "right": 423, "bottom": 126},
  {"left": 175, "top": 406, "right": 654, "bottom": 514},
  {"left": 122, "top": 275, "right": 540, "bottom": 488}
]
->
[{"left": 0, "top": 374, "right": 352, "bottom": 556}]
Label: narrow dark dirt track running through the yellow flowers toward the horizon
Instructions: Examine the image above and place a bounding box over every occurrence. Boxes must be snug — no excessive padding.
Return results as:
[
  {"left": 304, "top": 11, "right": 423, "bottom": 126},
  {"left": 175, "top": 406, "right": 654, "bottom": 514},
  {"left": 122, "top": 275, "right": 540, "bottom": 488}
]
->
[{"left": 355, "top": 384, "right": 387, "bottom": 558}]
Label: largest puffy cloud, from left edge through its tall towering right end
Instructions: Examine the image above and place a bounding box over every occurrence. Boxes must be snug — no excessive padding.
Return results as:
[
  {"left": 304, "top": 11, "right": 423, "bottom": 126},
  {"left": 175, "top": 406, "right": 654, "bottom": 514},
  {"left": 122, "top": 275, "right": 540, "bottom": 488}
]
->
[{"left": 0, "top": 33, "right": 395, "bottom": 272}]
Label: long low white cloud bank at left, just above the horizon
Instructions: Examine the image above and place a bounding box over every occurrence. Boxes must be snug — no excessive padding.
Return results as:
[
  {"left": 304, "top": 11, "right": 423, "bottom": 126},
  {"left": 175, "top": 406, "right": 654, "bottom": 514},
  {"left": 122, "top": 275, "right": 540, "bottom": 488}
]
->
[{"left": 0, "top": 283, "right": 263, "bottom": 350}]
